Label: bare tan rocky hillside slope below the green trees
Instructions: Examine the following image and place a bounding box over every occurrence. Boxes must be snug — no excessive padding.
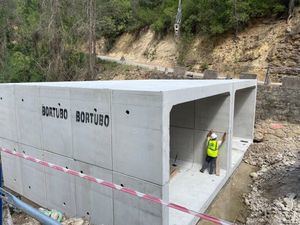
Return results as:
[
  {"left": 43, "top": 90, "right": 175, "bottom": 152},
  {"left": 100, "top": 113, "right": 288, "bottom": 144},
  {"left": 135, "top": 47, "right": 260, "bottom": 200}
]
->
[{"left": 98, "top": 8, "right": 300, "bottom": 81}]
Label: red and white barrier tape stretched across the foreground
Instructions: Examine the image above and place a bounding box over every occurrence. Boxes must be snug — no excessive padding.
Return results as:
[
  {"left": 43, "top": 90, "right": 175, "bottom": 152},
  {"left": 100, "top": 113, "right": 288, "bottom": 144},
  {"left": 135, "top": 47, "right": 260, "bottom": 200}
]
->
[{"left": 0, "top": 147, "right": 234, "bottom": 225}]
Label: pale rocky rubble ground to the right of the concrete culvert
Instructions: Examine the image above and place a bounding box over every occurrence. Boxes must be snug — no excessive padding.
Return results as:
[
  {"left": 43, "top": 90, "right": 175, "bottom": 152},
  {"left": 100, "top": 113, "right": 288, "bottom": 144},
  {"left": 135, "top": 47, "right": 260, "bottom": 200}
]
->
[{"left": 244, "top": 121, "right": 300, "bottom": 225}]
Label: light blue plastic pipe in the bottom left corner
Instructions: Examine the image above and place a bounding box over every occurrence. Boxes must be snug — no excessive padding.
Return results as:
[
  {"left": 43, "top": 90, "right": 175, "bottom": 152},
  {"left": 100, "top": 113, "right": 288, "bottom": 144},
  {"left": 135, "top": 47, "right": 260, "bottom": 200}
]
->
[{"left": 0, "top": 188, "right": 60, "bottom": 225}]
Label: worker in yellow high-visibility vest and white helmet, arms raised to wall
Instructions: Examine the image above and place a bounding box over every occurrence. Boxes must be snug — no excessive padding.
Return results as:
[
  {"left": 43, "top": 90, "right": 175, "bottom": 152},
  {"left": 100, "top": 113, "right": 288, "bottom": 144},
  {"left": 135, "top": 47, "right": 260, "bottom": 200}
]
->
[{"left": 200, "top": 131, "right": 226, "bottom": 174}]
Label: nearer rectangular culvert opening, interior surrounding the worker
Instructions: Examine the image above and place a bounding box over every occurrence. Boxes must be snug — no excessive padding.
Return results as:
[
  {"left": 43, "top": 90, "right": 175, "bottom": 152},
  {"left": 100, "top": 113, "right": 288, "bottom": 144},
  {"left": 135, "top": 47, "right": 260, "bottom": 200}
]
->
[{"left": 169, "top": 93, "right": 230, "bottom": 225}]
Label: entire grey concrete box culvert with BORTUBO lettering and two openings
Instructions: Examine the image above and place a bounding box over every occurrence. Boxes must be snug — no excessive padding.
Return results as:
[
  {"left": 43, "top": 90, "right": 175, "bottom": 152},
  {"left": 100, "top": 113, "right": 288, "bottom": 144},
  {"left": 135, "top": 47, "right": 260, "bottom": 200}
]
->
[{"left": 0, "top": 80, "right": 256, "bottom": 225}]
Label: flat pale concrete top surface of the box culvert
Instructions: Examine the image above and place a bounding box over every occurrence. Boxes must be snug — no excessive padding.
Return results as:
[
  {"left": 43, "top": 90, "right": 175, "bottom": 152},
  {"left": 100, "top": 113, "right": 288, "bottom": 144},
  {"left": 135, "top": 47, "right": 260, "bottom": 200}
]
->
[{"left": 0, "top": 79, "right": 256, "bottom": 92}]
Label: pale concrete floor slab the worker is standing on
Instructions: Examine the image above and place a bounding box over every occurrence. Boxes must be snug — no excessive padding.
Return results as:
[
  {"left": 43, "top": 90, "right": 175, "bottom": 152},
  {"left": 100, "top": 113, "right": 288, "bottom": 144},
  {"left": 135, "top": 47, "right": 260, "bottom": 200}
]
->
[{"left": 169, "top": 165, "right": 226, "bottom": 225}]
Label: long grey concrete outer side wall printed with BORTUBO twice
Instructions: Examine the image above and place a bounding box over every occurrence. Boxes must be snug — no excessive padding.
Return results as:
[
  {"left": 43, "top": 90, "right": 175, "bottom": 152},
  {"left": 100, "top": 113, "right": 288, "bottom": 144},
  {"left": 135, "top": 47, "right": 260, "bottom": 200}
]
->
[{"left": 0, "top": 85, "right": 168, "bottom": 225}]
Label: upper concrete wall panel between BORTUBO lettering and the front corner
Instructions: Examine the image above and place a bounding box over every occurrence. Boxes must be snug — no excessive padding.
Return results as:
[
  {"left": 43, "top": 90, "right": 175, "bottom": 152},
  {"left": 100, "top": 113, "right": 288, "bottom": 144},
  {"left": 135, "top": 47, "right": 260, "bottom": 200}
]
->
[{"left": 112, "top": 91, "right": 163, "bottom": 185}]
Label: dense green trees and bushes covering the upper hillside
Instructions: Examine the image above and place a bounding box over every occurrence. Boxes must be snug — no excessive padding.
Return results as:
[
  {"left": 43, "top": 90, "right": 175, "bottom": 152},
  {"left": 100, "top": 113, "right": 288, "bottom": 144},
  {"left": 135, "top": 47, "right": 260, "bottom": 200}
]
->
[{"left": 0, "top": 0, "right": 296, "bottom": 82}]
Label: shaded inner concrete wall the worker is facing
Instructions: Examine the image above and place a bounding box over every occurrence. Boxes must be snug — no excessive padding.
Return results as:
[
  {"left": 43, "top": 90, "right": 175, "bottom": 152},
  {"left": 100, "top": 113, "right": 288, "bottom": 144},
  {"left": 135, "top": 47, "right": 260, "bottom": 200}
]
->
[{"left": 170, "top": 94, "right": 230, "bottom": 169}]
